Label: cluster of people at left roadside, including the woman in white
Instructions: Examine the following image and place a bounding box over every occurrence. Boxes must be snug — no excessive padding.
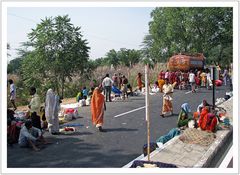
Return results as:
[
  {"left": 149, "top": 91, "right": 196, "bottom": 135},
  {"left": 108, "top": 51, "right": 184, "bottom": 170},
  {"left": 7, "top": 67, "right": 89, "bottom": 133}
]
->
[{"left": 7, "top": 80, "right": 61, "bottom": 151}]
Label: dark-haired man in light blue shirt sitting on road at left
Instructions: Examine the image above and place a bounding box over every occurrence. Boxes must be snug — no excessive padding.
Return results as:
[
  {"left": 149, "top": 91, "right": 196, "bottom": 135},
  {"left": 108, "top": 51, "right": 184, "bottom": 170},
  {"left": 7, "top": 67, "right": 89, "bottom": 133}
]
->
[{"left": 18, "top": 120, "right": 47, "bottom": 151}]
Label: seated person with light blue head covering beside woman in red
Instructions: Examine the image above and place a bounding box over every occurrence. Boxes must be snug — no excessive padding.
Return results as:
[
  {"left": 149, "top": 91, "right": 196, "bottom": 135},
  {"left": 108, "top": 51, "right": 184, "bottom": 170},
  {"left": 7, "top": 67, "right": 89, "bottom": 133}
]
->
[{"left": 177, "top": 103, "right": 192, "bottom": 127}]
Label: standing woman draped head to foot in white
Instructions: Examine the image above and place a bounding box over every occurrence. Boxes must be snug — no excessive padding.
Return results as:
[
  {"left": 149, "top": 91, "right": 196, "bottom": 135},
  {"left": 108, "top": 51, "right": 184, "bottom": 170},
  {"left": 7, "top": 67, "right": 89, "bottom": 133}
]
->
[{"left": 45, "top": 89, "right": 60, "bottom": 134}]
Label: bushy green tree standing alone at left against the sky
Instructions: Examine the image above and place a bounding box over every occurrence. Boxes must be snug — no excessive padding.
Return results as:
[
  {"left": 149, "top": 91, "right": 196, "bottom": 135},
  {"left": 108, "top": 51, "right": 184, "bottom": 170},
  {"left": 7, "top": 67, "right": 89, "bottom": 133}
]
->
[{"left": 22, "top": 15, "right": 89, "bottom": 96}]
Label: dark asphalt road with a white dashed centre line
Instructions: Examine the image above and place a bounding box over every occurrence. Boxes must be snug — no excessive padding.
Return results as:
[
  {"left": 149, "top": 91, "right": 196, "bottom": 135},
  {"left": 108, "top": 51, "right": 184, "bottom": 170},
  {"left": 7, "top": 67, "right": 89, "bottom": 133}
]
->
[{"left": 7, "top": 87, "right": 228, "bottom": 168}]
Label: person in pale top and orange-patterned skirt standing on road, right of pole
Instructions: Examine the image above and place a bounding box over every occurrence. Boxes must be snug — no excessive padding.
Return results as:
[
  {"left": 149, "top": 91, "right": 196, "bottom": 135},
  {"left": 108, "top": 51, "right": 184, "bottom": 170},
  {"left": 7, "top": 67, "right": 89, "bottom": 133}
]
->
[{"left": 160, "top": 79, "right": 173, "bottom": 118}]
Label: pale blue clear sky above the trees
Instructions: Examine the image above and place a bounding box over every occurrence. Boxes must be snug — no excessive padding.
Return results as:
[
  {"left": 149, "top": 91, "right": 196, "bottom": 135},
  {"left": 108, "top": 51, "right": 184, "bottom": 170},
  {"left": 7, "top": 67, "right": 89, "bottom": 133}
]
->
[{"left": 7, "top": 7, "right": 154, "bottom": 60}]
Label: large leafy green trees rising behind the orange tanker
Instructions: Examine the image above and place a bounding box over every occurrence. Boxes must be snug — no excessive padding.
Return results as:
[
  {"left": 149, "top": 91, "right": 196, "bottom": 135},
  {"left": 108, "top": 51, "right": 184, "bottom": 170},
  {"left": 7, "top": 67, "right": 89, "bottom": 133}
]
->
[{"left": 146, "top": 7, "right": 233, "bottom": 65}]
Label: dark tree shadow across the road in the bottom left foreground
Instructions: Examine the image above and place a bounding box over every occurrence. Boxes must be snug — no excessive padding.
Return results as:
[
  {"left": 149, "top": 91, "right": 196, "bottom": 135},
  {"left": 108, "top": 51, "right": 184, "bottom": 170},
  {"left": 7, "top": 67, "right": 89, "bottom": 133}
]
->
[{"left": 7, "top": 137, "right": 140, "bottom": 168}]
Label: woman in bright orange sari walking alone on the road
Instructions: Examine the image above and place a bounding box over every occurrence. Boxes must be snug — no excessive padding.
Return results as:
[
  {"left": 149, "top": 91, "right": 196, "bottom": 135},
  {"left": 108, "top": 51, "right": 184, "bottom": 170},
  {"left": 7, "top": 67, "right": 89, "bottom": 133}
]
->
[{"left": 91, "top": 87, "right": 106, "bottom": 132}]
